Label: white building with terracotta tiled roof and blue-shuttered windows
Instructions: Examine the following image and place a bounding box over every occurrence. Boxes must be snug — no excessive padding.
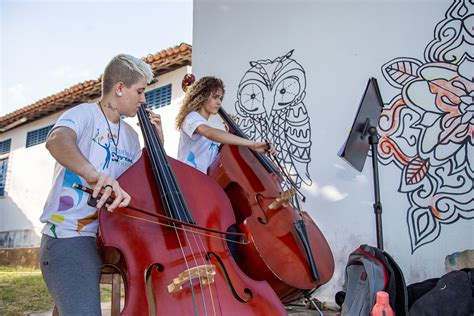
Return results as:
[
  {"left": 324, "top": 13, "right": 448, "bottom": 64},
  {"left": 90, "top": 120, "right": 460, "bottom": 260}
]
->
[{"left": 0, "top": 43, "right": 192, "bottom": 248}]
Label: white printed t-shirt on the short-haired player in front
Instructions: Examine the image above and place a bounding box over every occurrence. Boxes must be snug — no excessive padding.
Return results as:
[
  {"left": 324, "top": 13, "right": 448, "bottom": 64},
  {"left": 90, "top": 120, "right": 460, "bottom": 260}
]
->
[{"left": 40, "top": 103, "right": 141, "bottom": 238}]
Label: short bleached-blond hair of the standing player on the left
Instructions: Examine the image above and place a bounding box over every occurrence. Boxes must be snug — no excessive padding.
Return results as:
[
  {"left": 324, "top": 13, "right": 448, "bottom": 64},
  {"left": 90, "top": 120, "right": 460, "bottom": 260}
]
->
[{"left": 102, "top": 54, "right": 153, "bottom": 95}]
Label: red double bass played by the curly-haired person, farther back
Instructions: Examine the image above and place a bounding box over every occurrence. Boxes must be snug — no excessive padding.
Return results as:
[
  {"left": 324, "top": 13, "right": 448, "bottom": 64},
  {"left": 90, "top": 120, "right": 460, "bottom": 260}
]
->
[{"left": 182, "top": 75, "right": 334, "bottom": 303}]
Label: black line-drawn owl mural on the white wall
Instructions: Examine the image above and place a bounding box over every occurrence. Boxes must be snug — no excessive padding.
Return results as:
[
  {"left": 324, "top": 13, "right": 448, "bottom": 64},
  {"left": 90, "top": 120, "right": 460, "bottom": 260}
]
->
[{"left": 235, "top": 50, "right": 311, "bottom": 188}]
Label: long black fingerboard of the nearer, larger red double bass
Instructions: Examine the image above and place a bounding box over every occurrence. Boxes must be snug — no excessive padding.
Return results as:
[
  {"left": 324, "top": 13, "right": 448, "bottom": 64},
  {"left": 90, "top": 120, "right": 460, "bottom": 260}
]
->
[{"left": 138, "top": 105, "right": 195, "bottom": 223}]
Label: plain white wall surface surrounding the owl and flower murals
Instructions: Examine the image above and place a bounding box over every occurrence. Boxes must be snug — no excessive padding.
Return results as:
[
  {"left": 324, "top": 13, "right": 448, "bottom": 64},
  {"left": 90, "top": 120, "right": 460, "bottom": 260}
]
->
[{"left": 193, "top": 0, "right": 474, "bottom": 300}]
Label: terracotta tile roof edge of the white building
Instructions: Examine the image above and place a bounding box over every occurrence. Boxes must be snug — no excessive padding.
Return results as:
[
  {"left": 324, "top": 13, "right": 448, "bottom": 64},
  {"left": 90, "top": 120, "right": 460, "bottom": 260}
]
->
[{"left": 0, "top": 43, "right": 192, "bottom": 132}]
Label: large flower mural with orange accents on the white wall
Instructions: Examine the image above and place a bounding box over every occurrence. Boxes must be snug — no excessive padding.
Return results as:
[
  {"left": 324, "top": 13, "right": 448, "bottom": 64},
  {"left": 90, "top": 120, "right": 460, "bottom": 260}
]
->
[{"left": 378, "top": 0, "right": 474, "bottom": 253}]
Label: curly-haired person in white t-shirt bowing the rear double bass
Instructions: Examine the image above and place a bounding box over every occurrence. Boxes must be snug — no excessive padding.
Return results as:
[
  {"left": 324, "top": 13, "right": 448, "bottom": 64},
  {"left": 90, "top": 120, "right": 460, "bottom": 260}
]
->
[{"left": 176, "top": 77, "right": 275, "bottom": 173}]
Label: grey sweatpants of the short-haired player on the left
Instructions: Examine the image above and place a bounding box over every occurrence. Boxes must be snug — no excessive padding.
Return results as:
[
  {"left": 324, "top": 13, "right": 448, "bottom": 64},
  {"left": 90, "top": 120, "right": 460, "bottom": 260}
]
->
[{"left": 40, "top": 234, "right": 101, "bottom": 316}]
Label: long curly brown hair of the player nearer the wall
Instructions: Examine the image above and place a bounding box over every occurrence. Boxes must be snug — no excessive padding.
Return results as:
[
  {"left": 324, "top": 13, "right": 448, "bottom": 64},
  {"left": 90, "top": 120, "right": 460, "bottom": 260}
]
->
[{"left": 176, "top": 76, "right": 225, "bottom": 130}]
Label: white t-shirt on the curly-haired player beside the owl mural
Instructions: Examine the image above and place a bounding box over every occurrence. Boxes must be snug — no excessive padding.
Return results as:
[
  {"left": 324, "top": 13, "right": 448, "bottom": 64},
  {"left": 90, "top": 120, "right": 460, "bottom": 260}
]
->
[{"left": 178, "top": 112, "right": 219, "bottom": 173}]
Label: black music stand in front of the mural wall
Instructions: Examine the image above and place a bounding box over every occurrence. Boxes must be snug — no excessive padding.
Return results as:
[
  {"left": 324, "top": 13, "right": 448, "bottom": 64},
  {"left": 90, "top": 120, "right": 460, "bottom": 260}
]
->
[{"left": 338, "top": 78, "right": 383, "bottom": 250}]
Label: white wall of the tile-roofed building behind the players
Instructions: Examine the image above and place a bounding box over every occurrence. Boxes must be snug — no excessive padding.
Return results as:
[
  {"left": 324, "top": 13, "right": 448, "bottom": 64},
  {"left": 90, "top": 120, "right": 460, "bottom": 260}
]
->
[{"left": 0, "top": 66, "right": 191, "bottom": 247}]
